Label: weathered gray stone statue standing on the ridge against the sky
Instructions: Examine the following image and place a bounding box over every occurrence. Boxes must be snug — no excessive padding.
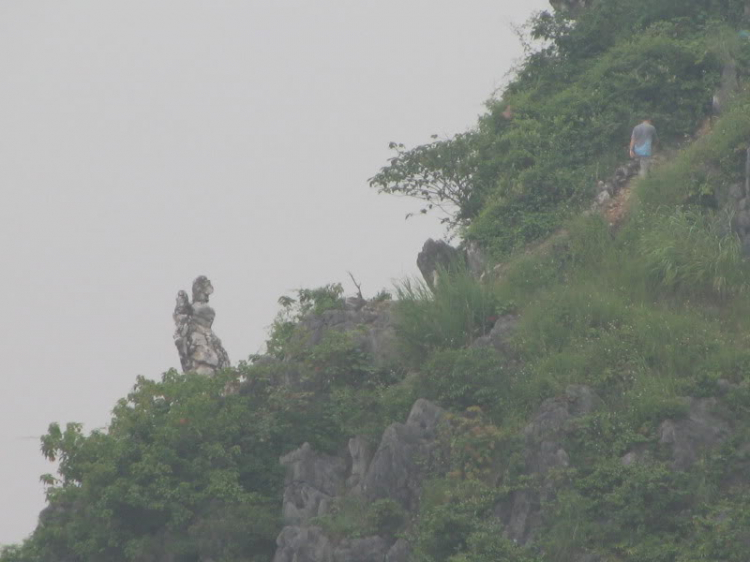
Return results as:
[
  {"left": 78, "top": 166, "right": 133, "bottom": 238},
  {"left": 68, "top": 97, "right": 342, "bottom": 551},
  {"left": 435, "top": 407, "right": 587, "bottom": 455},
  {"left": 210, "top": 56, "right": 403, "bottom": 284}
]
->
[{"left": 172, "top": 275, "right": 230, "bottom": 375}]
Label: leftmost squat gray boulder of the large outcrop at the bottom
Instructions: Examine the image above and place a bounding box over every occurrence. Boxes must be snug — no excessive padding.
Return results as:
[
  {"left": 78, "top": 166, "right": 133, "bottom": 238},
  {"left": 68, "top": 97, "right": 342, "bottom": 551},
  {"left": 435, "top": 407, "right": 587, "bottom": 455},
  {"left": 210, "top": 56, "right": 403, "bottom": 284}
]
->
[{"left": 280, "top": 443, "right": 346, "bottom": 526}]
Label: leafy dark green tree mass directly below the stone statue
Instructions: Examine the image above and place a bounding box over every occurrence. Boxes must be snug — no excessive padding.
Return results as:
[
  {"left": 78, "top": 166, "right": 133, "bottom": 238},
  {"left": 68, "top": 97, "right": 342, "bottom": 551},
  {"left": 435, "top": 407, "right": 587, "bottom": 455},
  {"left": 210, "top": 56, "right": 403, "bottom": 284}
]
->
[{"left": 16, "top": 371, "right": 288, "bottom": 562}]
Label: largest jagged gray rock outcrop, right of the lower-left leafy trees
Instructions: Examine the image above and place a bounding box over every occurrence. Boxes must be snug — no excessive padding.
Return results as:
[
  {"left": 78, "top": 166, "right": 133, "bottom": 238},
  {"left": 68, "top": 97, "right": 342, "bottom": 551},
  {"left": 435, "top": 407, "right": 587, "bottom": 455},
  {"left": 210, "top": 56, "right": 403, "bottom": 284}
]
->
[{"left": 274, "top": 399, "right": 444, "bottom": 562}]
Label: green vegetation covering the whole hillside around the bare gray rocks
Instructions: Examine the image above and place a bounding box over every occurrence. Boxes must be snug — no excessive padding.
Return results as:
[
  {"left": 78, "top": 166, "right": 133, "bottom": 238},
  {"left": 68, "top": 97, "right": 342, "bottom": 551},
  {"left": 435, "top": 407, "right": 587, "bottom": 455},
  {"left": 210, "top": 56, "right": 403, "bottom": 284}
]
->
[{"left": 7, "top": 0, "right": 750, "bottom": 562}]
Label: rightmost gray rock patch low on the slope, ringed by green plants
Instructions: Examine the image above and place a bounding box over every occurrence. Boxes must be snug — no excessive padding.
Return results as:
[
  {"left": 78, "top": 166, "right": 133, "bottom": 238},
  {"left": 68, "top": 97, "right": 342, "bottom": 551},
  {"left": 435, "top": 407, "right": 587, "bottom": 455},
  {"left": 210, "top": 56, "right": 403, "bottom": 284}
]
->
[{"left": 659, "top": 398, "right": 730, "bottom": 470}]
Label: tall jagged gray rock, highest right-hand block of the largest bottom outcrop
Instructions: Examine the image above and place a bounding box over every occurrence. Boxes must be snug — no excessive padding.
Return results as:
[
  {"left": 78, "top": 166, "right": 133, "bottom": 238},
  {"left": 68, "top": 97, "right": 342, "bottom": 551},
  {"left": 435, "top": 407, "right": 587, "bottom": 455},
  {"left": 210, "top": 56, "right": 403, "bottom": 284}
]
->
[{"left": 362, "top": 398, "right": 445, "bottom": 511}]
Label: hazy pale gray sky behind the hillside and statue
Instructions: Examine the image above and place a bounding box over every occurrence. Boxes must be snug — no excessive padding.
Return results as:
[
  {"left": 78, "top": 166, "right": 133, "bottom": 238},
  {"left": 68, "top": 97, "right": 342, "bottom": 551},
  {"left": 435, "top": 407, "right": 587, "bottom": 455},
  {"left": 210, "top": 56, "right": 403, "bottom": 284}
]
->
[{"left": 0, "top": 0, "right": 547, "bottom": 544}]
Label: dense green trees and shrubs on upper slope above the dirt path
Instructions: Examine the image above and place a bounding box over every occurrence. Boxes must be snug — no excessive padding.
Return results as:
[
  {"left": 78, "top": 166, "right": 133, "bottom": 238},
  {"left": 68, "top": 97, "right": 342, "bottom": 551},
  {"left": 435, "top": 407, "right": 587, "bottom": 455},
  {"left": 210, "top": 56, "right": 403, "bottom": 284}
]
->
[{"left": 370, "top": 0, "right": 744, "bottom": 255}]
